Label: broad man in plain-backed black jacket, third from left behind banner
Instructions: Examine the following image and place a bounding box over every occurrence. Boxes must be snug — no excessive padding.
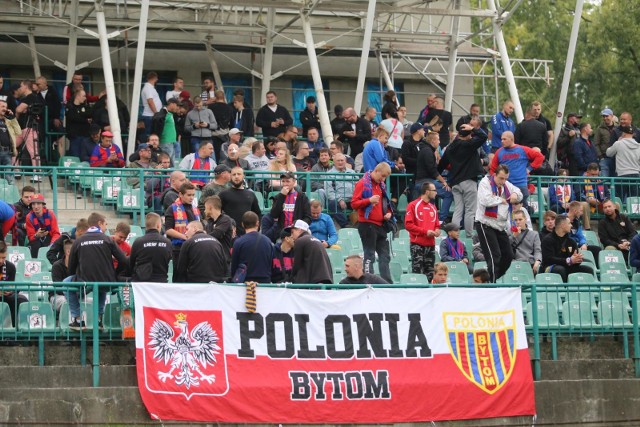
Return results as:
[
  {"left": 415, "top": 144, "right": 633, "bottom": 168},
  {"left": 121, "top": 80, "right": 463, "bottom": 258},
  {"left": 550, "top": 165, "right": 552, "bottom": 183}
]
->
[{"left": 174, "top": 221, "right": 228, "bottom": 283}]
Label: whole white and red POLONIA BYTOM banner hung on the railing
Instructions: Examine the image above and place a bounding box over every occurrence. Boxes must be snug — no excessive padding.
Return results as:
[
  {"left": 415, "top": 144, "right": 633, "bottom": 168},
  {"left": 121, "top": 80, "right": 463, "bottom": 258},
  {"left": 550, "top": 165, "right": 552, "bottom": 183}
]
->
[{"left": 133, "top": 283, "right": 535, "bottom": 424}]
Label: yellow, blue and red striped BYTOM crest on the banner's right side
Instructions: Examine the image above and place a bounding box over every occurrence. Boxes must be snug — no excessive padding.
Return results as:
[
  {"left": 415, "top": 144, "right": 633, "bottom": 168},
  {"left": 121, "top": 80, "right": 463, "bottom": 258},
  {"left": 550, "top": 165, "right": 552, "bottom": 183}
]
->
[{"left": 443, "top": 310, "right": 516, "bottom": 394}]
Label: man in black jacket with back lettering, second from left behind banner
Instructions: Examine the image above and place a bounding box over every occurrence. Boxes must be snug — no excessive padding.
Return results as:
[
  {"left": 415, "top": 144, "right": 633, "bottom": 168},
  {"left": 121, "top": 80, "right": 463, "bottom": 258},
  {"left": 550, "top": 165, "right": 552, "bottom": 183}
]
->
[{"left": 129, "top": 212, "right": 172, "bottom": 283}]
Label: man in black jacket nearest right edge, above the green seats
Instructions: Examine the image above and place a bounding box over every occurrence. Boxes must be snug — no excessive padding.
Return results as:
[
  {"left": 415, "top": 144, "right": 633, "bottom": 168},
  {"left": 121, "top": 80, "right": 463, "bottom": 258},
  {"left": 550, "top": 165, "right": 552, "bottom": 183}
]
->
[{"left": 598, "top": 200, "right": 637, "bottom": 261}]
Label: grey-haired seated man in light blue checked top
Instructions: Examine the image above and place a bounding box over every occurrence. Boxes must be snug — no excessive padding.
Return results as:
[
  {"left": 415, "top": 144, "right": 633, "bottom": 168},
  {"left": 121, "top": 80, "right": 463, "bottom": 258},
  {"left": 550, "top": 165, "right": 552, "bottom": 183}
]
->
[{"left": 324, "top": 153, "right": 357, "bottom": 227}]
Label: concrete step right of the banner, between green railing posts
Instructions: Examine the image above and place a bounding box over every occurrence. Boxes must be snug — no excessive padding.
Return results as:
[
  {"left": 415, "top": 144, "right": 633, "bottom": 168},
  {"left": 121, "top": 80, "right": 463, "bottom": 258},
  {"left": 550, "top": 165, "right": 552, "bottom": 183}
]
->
[{"left": 540, "top": 359, "right": 635, "bottom": 380}]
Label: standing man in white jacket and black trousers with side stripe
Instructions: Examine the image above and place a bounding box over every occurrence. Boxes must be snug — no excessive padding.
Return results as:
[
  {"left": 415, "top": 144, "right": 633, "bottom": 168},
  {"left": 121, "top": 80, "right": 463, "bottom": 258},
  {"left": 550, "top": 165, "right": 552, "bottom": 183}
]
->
[{"left": 476, "top": 166, "right": 522, "bottom": 283}]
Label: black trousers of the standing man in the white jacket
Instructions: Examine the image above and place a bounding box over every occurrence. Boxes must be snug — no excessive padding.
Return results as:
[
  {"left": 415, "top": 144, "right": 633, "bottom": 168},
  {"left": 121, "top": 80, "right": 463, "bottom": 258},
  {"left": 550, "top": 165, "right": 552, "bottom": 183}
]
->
[{"left": 475, "top": 222, "right": 513, "bottom": 283}]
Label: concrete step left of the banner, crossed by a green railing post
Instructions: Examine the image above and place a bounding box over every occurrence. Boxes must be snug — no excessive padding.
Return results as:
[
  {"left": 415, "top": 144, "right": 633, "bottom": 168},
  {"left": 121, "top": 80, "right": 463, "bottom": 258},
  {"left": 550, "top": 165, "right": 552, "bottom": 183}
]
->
[{"left": 0, "top": 365, "right": 138, "bottom": 390}]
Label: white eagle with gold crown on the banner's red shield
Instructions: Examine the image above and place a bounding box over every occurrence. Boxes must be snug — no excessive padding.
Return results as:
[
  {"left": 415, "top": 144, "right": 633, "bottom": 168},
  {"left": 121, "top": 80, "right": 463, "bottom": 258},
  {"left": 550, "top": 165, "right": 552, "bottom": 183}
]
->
[{"left": 148, "top": 313, "right": 220, "bottom": 389}]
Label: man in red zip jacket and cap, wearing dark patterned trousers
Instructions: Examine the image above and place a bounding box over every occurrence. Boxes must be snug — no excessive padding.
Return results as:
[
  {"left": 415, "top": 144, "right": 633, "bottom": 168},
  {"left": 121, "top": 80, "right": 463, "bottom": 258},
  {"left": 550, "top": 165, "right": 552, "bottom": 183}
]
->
[{"left": 404, "top": 181, "right": 440, "bottom": 282}]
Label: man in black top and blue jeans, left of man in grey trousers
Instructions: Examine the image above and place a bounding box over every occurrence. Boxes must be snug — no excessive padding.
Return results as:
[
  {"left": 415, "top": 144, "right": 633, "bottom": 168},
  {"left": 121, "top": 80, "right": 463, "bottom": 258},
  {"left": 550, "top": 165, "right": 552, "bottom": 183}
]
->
[{"left": 413, "top": 132, "right": 453, "bottom": 222}]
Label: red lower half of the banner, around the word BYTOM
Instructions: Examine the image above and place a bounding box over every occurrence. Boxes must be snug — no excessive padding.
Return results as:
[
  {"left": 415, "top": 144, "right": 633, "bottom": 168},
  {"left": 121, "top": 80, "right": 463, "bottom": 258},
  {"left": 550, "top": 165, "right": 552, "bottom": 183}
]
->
[{"left": 137, "top": 349, "right": 535, "bottom": 424}]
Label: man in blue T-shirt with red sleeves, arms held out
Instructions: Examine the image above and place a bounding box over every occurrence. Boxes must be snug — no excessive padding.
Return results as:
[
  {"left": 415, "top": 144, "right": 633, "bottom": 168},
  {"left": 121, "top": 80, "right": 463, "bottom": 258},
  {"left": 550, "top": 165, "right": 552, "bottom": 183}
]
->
[{"left": 490, "top": 131, "right": 544, "bottom": 206}]
